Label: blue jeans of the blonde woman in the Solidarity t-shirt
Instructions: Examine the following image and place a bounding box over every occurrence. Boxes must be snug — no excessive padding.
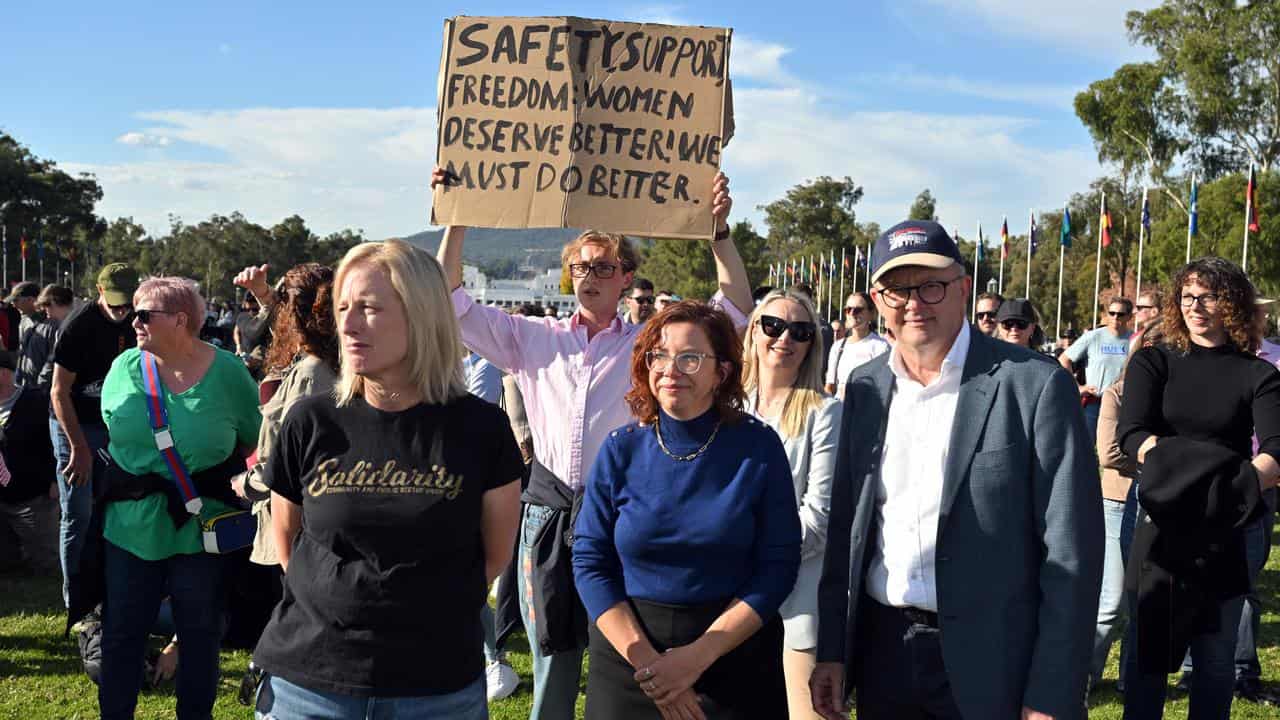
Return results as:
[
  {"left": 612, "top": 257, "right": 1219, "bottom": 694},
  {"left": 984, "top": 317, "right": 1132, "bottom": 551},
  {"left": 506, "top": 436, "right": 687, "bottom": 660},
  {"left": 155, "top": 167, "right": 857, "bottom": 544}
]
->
[{"left": 253, "top": 675, "right": 489, "bottom": 720}]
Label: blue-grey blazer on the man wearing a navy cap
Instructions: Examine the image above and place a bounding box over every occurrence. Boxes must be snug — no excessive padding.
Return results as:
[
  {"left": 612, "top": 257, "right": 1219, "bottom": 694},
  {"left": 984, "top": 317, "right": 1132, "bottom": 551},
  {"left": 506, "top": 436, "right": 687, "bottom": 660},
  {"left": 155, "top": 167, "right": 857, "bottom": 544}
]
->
[{"left": 818, "top": 331, "right": 1105, "bottom": 720}]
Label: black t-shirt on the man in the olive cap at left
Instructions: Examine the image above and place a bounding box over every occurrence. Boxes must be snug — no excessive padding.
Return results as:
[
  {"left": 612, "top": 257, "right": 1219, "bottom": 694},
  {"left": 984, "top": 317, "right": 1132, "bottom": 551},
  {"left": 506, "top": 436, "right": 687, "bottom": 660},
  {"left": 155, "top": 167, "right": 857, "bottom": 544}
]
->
[{"left": 50, "top": 302, "right": 138, "bottom": 425}]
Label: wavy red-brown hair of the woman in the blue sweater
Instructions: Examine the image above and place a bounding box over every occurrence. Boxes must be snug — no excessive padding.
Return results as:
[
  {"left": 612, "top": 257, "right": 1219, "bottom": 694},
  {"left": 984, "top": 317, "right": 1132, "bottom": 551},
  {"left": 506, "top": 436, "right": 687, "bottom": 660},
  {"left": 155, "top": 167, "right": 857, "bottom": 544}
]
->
[{"left": 626, "top": 300, "right": 746, "bottom": 424}]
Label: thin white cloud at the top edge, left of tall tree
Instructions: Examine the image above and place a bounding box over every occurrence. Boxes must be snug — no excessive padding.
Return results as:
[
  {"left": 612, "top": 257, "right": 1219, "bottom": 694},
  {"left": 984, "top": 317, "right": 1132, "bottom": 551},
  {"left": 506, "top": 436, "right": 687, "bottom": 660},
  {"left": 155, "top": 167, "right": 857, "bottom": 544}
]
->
[{"left": 916, "top": 0, "right": 1161, "bottom": 60}]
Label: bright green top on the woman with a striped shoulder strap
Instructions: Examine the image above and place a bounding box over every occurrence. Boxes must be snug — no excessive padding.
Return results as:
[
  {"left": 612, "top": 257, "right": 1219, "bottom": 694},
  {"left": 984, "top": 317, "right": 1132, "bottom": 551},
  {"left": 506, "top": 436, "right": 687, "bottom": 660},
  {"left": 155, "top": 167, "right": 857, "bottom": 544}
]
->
[{"left": 102, "top": 347, "right": 262, "bottom": 560}]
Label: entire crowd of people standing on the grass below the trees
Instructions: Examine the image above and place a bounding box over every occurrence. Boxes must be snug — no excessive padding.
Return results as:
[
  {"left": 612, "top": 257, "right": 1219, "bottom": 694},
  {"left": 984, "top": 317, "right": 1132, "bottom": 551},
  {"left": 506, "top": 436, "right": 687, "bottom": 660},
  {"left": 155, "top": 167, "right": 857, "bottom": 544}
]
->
[{"left": 0, "top": 170, "right": 1280, "bottom": 720}]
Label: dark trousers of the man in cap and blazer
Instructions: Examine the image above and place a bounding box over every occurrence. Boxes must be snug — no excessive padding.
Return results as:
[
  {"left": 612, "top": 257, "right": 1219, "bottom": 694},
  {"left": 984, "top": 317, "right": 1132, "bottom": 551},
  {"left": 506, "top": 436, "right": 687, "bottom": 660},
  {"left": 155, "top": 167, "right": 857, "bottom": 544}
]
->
[{"left": 855, "top": 596, "right": 961, "bottom": 720}]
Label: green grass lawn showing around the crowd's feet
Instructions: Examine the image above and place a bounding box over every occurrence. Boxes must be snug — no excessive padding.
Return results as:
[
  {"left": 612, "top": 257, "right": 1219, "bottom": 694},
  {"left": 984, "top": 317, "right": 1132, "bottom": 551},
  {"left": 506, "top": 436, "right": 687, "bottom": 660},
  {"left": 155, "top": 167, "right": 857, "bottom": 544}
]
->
[{"left": 0, "top": 543, "right": 1280, "bottom": 720}]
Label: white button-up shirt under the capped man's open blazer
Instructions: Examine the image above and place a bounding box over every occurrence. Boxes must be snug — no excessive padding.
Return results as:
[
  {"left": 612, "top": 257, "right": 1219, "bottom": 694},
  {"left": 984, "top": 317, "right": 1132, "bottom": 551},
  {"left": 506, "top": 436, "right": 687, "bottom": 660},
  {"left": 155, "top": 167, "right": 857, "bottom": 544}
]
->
[{"left": 867, "top": 323, "right": 969, "bottom": 612}]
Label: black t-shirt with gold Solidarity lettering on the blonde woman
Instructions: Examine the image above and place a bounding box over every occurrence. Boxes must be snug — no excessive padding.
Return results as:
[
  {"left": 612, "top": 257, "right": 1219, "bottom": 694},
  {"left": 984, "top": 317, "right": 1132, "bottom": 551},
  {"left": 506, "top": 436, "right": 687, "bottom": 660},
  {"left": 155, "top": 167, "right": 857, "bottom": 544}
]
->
[{"left": 253, "top": 395, "right": 524, "bottom": 696}]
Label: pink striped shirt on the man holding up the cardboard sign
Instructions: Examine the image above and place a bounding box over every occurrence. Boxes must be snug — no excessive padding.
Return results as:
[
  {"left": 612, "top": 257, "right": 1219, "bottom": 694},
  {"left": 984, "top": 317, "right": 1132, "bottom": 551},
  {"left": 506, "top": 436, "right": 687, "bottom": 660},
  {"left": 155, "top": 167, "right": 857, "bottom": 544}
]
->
[{"left": 453, "top": 287, "right": 746, "bottom": 491}]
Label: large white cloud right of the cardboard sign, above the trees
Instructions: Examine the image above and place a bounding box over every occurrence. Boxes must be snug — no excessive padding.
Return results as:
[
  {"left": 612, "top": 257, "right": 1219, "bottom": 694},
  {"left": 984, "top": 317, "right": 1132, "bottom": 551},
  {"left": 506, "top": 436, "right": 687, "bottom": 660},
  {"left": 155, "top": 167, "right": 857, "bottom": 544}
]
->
[{"left": 724, "top": 90, "right": 1098, "bottom": 232}]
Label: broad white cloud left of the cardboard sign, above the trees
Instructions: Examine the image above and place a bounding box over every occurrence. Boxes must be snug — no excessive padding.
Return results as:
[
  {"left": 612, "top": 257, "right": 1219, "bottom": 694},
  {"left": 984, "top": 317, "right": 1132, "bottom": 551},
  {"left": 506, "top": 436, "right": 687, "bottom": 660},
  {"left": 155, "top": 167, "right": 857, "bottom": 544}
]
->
[{"left": 76, "top": 108, "right": 445, "bottom": 237}]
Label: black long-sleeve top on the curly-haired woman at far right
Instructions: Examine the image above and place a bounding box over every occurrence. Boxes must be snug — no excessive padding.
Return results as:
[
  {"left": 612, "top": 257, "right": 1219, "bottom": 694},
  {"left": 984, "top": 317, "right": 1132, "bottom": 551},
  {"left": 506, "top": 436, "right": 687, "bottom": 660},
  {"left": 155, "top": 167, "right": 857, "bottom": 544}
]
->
[{"left": 1116, "top": 345, "right": 1280, "bottom": 460}]
